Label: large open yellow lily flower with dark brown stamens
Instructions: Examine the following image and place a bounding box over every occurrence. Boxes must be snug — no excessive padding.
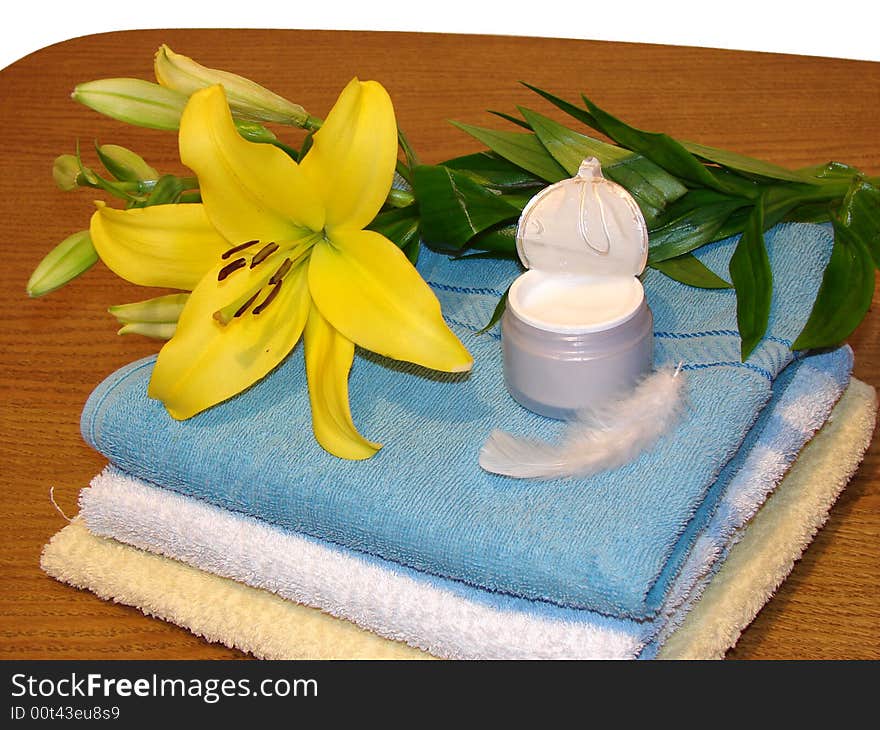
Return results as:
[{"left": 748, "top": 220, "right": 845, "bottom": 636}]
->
[{"left": 91, "top": 79, "right": 473, "bottom": 459}]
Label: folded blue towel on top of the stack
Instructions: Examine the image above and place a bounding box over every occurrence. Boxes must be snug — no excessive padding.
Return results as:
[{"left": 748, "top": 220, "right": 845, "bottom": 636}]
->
[{"left": 82, "top": 224, "right": 832, "bottom": 619}]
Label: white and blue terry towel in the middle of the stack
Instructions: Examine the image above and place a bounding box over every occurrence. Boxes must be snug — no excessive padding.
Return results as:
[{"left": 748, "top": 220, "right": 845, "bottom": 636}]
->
[{"left": 80, "top": 349, "right": 851, "bottom": 658}]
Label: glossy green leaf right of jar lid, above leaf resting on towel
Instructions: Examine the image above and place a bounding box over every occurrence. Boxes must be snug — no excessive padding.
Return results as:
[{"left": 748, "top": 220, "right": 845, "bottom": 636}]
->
[{"left": 648, "top": 189, "right": 749, "bottom": 266}]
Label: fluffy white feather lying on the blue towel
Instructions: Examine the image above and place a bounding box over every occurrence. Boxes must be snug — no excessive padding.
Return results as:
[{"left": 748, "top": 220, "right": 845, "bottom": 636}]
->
[{"left": 480, "top": 366, "right": 685, "bottom": 479}]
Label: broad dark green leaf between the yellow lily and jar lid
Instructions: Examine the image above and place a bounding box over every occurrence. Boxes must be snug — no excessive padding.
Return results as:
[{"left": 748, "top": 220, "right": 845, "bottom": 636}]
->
[{"left": 413, "top": 165, "right": 520, "bottom": 250}]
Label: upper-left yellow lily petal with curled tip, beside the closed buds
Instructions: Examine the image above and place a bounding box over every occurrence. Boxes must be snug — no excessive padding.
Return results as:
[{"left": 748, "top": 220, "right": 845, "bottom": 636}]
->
[{"left": 180, "top": 86, "right": 324, "bottom": 242}]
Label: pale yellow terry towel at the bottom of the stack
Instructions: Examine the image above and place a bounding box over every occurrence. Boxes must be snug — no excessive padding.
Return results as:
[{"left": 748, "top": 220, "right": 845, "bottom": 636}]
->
[{"left": 42, "top": 380, "right": 877, "bottom": 659}]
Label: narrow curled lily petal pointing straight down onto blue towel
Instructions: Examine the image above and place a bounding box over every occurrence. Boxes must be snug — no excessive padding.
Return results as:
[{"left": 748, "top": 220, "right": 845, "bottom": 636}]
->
[{"left": 304, "top": 307, "right": 382, "bottom": 459}]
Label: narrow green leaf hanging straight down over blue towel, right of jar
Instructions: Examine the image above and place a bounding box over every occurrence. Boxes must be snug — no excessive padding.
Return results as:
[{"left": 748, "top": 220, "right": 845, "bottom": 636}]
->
[{"left": 729, "top": 199, "right": 773, "bottom": 362}]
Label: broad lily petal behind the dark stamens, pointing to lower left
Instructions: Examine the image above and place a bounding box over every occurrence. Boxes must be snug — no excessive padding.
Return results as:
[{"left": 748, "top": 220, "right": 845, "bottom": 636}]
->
[{"left": 148, "top": 253, "right": 311, "bottom": 419}]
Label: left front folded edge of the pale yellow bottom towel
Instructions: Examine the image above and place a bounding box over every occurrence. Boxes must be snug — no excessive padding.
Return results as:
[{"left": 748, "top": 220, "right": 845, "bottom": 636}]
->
[{"left": 40, "top": 519, "right": 431, "bottom": 659}]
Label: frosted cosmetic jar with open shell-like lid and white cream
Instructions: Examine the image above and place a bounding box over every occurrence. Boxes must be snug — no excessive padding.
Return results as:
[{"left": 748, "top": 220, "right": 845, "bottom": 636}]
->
[{"left": 501, "top": 158, "right": 654, "bottom": 418}]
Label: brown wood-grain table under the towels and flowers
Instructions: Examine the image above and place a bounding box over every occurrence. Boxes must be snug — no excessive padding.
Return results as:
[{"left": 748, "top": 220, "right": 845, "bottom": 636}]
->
[{"left": 0, "top": 30, "right": 880, "bottom": 659}]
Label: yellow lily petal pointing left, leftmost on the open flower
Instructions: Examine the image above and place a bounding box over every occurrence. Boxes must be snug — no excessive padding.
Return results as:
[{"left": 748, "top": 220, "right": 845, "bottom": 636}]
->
[{"left": 90, "top": 201, "right": 229, "bottom": 290}]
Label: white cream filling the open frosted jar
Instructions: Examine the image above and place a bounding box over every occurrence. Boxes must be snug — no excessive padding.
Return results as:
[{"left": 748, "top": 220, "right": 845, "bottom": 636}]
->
[{"left": 508, "top": 269, "right": 645, "bottom": 334}]
